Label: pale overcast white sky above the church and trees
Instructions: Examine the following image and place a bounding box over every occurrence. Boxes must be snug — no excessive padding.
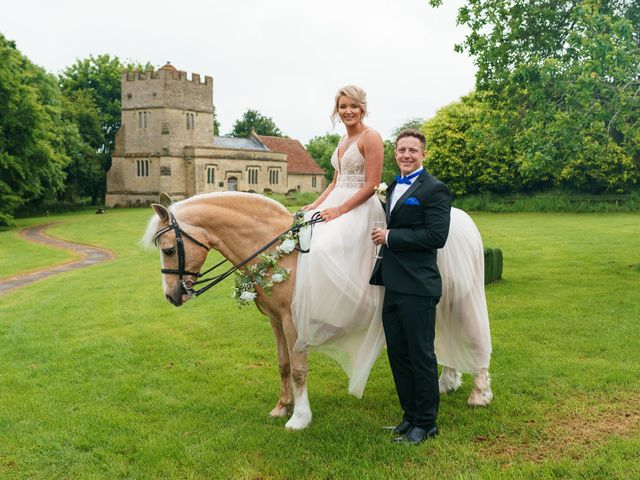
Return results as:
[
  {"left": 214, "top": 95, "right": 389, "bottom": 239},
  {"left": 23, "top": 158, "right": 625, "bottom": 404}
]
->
[{"left": 0, "top": 0, "right": 475, "bottom": 143}]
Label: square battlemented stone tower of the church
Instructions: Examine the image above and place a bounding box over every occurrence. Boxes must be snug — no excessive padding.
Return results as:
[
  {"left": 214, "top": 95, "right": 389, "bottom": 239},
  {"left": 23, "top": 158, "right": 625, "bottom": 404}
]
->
[{"left": 105, "top": 63, "right": 213, "bottom": 206}]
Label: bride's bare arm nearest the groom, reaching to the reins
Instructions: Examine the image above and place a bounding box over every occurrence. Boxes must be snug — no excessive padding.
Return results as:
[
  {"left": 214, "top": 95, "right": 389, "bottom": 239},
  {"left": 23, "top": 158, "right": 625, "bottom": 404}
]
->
[{"left": 320, "top": 130, "right": 384, "bottom": 221}]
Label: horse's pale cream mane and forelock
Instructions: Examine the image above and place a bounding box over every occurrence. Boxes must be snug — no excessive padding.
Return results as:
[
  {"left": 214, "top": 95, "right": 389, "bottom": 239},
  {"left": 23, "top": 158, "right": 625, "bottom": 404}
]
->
[{"left": 140, "top": 192, "right": 291, "bottom": 249}]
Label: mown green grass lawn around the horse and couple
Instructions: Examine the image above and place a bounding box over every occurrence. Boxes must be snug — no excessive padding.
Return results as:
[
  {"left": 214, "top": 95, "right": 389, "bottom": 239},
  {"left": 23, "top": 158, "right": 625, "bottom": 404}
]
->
[{"left": 0, "top": 210, "right": 640, "bottom": 479}]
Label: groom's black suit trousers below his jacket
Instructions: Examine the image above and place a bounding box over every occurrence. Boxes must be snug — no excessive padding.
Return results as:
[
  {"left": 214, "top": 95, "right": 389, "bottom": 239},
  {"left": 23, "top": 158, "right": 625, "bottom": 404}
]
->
[{"left": 382, "top": 289, "right": 440, "bottom": 429}]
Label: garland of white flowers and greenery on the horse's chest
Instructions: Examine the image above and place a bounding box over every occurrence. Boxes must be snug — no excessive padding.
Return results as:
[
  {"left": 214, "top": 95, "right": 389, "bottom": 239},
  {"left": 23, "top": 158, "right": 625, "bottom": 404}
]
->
[{"left": 233, "top": 210, "right": 306, "bottom": 306}]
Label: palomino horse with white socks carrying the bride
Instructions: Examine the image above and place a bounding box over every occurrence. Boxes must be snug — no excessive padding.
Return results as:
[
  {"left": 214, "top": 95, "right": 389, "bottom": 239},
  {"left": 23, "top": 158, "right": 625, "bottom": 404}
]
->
[{"left": 143, "top": 192, "right": 492, "bottom": 430}]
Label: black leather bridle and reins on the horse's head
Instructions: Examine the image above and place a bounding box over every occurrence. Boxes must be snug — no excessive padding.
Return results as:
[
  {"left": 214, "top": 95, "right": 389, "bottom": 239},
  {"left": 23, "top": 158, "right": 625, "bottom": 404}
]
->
[{"left": 153, "top": 212, "right": 324, "bottom": 297}]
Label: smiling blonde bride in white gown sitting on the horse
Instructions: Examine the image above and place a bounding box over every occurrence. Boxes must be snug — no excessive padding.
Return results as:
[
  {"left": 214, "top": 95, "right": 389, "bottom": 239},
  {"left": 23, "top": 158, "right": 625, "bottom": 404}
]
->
[{"left": 291, "top": 85, "right": 385, "bottom": 397}]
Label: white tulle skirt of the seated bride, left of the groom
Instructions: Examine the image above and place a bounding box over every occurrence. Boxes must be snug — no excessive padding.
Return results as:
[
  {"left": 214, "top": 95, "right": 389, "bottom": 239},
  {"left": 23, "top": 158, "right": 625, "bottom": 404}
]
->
[{"left": 291, "top": 187, "right": 385, "bottom": 398}]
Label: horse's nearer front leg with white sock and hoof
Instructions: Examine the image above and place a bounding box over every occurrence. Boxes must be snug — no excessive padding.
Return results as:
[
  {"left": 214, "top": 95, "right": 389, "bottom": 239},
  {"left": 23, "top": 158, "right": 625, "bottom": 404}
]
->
[{"left": 282, "top": 317, "right": 312, "bottom": 430}]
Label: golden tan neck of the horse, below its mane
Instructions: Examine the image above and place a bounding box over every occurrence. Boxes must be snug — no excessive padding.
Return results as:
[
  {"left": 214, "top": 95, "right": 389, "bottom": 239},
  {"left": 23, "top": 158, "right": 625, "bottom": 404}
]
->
[{"left": 180, "top": 199, "right": 291, "bottom": 264}]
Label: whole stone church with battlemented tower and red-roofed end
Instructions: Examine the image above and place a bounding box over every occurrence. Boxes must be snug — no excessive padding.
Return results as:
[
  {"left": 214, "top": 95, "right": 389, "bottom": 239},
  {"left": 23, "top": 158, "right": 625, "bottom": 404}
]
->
[{"left": 105, "top": 63, "right": 326, "bottom": 207}]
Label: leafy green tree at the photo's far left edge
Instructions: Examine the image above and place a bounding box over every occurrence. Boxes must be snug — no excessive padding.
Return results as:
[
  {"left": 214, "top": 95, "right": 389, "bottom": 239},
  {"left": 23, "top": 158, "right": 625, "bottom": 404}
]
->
[{"left": 0, "top": 34, "right": 73, "bottom": 225}]
